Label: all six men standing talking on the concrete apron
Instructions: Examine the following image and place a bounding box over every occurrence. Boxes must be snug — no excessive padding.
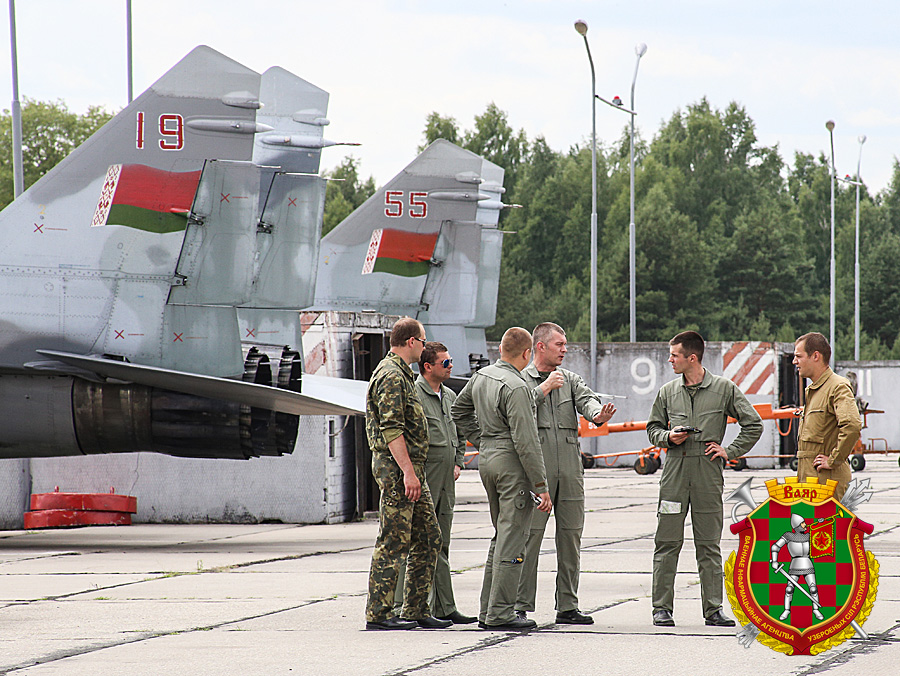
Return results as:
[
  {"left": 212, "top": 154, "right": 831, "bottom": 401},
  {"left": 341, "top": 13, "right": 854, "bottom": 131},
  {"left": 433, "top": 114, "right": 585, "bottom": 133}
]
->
[{"left": 366, "top": 318, "right": 860, "bottom": 630}]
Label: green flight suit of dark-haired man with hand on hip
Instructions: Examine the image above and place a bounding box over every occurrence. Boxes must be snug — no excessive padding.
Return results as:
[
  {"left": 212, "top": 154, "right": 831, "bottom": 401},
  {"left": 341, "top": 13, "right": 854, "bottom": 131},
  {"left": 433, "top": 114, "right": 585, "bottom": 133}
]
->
[{"left": 647, "top": 369, "right": 763, "bottom": 618}]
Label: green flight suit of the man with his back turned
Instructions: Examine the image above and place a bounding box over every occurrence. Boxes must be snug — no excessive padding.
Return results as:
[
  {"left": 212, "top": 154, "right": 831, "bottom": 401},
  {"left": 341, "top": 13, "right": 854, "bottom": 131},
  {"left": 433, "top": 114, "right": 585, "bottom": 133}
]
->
[{"left": 452, "top": 359, "right": 547, "bottom": 625}]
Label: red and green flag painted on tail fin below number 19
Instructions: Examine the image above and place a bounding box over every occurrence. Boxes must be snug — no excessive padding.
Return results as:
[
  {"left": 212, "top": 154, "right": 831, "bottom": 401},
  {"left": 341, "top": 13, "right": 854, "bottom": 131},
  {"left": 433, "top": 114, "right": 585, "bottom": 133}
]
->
[{"left": 91, "top": 164, "right": 200, "bottom": 233}]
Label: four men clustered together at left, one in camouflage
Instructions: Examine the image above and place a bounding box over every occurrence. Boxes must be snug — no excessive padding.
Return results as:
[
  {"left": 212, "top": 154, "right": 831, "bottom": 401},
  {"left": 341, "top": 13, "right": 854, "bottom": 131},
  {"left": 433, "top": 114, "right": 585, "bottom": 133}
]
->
[{"left": 366, "top": 318, "right": 615, "bottom": 629}]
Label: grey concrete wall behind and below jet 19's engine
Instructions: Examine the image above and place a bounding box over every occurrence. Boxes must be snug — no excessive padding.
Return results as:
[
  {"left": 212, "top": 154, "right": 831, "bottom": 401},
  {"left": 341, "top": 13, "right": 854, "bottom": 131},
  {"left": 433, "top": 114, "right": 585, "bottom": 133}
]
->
[{"left": 0, "top": 312, "right": 392, "bottom": 529}]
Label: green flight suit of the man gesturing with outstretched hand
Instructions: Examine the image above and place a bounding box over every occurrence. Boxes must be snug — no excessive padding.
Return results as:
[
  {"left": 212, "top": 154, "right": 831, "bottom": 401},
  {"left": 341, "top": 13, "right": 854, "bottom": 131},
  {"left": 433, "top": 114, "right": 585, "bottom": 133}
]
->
[{"left": 516, "top": 362, "right": 603, "bottom": 613}]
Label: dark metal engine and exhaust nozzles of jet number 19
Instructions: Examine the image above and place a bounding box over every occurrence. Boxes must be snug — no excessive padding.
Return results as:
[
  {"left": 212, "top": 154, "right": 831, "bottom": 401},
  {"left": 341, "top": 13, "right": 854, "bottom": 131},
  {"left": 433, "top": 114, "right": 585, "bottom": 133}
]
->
[{"left": 0, "top": 348, "right": 302, "bottom": 460}]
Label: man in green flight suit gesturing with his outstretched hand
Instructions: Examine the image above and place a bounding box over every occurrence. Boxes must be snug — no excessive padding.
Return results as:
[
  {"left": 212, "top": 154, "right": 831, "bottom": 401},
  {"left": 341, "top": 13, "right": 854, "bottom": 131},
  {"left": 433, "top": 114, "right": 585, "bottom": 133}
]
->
[{"left": 516, "top": 322, "right": 616, "bottom": 624}]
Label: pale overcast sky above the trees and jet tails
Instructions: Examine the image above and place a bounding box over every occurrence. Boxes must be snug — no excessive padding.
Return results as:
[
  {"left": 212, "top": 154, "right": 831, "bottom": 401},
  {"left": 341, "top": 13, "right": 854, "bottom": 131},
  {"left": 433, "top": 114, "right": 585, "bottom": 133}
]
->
[{"left": 0, "top": 0, "right": 900, "bottom": 191}]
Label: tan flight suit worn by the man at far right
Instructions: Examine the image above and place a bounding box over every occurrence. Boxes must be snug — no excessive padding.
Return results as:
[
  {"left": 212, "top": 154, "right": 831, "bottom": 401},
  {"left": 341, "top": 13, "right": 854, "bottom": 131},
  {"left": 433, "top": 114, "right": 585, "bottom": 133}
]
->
[{"left": 797, "top": 368, "right": 862, "bottom": 500}]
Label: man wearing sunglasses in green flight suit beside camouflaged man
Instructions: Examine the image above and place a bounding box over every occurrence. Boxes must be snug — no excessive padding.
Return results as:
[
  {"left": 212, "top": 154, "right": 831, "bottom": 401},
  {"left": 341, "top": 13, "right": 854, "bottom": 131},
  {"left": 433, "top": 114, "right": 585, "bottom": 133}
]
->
[{"left": 394, "top": 342, "right": 477, "bottom": 624}]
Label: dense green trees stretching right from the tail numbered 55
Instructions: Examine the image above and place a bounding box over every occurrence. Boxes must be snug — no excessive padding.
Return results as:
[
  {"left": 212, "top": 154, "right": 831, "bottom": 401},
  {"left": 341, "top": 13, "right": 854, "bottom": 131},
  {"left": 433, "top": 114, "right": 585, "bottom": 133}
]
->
[{"left": 424, "top": 99, "right": 900, "bottom": 359}]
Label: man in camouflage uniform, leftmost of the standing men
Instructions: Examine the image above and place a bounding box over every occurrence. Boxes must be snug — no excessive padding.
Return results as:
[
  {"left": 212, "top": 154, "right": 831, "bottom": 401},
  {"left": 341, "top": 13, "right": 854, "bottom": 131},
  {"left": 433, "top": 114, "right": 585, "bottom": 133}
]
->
[{"left": 366, "top": 317, "right": 452, "bottom": 629}]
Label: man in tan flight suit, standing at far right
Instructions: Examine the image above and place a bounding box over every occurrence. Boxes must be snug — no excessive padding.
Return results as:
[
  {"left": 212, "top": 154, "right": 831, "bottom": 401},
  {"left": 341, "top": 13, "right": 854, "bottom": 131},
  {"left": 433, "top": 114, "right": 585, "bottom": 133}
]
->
[{"left": 793, "top": 333, "right": 862, "bottom": 500}]
